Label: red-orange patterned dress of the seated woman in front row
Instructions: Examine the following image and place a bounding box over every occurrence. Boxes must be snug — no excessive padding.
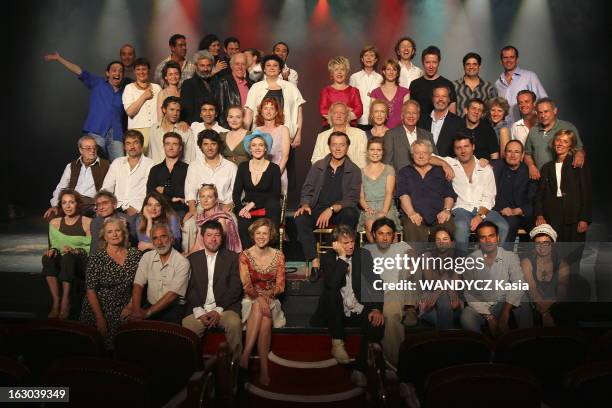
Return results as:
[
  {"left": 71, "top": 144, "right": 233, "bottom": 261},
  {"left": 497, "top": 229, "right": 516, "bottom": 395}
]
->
[{"left": 238, "top": 249, "right": 287, "bottom": 328}]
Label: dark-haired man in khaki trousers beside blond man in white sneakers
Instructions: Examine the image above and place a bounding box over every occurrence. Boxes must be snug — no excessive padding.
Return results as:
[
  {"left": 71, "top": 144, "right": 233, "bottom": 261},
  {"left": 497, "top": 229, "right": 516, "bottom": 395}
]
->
[{"left": 364, "top": 218, "right": 420, "bottom": 367}]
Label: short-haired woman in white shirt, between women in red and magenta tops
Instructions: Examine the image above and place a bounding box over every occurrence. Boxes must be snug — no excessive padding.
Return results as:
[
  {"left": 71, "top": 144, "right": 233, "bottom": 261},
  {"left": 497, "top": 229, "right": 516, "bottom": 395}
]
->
[{"left": 349, "top": 46, "right": 382, "bottom": 130}]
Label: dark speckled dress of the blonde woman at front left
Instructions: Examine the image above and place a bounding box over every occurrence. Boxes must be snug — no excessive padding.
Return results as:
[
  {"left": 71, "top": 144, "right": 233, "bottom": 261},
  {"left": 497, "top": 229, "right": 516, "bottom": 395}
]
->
[{"left": 80, "top": 248, "right": 141, "bottom": 349}]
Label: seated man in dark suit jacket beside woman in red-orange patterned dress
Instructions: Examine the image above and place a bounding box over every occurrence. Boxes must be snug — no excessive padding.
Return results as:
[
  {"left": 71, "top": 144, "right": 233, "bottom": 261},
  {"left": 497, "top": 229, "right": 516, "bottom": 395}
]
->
[{"left": 183, "top": 221, "right": 242, "bottom": 358}]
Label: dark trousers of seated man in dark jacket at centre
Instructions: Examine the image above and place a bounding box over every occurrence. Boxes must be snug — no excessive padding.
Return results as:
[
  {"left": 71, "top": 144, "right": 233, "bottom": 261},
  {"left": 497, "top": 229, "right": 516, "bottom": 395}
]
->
[{"left": 294, "top": 207, "right": 359, "bottom": 261}]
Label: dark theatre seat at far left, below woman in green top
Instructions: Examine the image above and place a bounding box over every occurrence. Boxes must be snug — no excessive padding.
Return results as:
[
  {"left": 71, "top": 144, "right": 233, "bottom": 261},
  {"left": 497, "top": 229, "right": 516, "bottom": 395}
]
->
[{"left": 8, "top": 319, "right": 104, "bottom": 378}]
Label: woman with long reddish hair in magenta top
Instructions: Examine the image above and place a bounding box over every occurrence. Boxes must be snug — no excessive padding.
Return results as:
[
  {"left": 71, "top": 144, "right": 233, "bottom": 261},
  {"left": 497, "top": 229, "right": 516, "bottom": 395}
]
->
[{"left": 370, "top": 59, "right": 410, "bottom": 129}]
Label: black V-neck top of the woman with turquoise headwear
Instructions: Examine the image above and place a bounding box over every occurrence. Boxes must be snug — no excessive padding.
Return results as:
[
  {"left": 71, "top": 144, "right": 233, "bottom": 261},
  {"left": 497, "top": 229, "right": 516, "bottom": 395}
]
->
[{"left": 232, "top": 160, "right": 280, "bottom": 213}]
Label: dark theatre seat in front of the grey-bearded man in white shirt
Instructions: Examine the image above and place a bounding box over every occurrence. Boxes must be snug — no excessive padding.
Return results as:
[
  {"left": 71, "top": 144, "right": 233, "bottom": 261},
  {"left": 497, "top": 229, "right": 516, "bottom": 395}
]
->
[{"left": 114, "top": 321, "right": 202, "bottom": 405}]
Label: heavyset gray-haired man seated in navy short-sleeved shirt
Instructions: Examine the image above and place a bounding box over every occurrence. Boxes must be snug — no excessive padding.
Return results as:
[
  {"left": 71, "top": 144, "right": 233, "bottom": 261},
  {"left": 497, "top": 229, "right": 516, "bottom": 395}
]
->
[{"left": 396, "top": 139, "right": 457, "bottom": 242}]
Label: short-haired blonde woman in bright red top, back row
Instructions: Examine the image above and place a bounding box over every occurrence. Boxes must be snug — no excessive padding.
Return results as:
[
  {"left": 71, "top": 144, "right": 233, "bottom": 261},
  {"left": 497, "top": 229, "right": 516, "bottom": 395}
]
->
[{"left": 319, "top": 57, "right": 363, "bottom": 128}]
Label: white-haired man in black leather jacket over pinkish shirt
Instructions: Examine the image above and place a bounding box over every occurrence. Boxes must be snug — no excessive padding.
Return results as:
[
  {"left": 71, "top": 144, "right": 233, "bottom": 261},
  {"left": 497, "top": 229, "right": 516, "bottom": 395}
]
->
[{"left": 212, "top": 52, "right": 253, "bottom": 128}]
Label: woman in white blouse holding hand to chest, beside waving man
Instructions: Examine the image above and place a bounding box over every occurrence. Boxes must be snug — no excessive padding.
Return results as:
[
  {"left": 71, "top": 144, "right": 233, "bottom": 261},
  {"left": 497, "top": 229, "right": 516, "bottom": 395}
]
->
[{"left": 122, "top": 58, "right": 161, "bottom": 154}]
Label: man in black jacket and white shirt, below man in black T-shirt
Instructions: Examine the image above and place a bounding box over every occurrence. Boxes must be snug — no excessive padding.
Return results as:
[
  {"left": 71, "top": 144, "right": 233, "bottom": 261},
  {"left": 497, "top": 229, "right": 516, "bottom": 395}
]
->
[{"left": 421, "top": 85, "right": 464, "bottom": 157}]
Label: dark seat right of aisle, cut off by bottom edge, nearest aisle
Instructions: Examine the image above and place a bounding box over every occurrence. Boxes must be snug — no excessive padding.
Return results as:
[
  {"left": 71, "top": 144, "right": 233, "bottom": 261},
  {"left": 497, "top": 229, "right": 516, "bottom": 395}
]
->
[{"left": 423, "top": 363, "right": 541, "bottom": 408}]
